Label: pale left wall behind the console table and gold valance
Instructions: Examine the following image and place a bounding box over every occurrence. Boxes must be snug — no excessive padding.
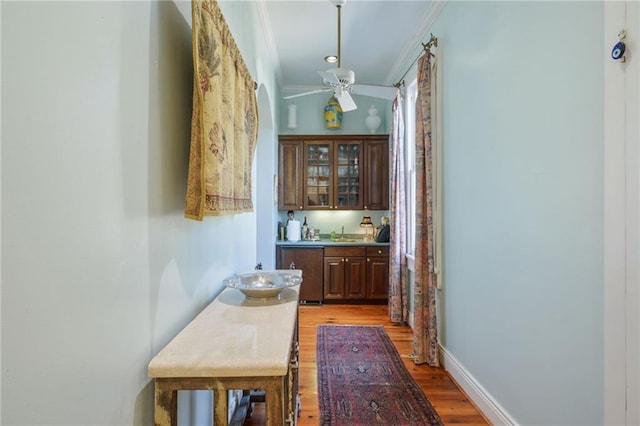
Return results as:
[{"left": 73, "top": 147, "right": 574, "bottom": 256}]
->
[{"left": 1, "top": 1, "right": 275, "bottom": 425}]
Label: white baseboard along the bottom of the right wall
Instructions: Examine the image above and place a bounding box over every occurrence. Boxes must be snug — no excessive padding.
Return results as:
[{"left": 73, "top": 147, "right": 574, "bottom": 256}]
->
[{"left": 439, "top": 345, "right": 517, "bottom": 425}]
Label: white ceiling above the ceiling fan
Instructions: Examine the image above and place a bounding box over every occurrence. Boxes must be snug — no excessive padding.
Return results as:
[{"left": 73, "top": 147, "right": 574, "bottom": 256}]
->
[{"left": 259, "top": 0, "right": 438, "bottom": 94}]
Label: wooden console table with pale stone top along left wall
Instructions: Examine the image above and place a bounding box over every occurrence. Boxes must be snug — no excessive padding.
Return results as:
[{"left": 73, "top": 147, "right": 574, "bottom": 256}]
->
[{"left": 148, "top": 270, "right": 302, "bottom": 426}]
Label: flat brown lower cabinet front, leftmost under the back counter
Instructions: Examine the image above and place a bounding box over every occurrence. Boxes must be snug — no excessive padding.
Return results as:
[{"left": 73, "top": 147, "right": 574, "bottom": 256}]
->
[{"left": 276, "top": 246, "right": 324, "bottom": 302}]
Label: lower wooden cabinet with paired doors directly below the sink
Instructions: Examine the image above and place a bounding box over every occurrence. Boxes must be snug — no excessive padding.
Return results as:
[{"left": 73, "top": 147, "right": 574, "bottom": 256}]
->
[{"left": 324, "top": 246, "right": 367, "bottom": 300}]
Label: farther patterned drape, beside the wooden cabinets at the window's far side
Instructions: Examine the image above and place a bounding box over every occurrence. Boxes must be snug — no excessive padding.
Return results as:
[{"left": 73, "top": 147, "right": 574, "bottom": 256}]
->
[{"left": 389, "top": 91, "right": 409, "bottom": 324}]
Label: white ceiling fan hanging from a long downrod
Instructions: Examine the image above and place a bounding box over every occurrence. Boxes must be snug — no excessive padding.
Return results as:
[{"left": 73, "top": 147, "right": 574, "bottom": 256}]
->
[{"left": 284, "top": 0, "right": 398, "bottom": 112}]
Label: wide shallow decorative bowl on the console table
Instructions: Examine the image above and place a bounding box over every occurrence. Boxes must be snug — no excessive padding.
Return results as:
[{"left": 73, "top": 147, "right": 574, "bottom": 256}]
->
[{"left": 223, "top": 271, "right": 302, "bottom": 299}]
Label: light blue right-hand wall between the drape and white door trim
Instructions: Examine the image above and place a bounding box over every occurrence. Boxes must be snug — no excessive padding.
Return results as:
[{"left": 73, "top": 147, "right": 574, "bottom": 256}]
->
[{"left": 430, "top": 1, "right": 605, "bottom": 425}]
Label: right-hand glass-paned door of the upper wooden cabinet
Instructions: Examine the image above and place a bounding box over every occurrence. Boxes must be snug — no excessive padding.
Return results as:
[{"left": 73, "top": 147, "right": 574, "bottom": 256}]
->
[{"left": 333, "top": 141, "right": 363, "bottom": 210}]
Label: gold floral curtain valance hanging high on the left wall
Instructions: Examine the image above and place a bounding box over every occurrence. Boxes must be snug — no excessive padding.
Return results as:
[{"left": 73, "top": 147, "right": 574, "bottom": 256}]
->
[{"left": 185, "top": 0, "right": 258, "bottom": 220}]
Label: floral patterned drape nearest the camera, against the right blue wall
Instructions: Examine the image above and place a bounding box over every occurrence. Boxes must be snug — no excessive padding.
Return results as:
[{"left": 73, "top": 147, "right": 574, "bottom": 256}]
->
[{"left": 413, "top": 50, "right": 440, "bottom": 366}]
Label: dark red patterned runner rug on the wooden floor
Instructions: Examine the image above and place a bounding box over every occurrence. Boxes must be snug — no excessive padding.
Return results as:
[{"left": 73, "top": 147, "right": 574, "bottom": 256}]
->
[{"left": 316, "top": 325, "right": 443, "bottom": 426}]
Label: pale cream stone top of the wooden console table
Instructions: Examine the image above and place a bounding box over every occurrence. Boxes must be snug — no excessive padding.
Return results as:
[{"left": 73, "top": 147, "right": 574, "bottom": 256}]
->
[{"left": 148, "top": 270, "right": 302, "bottom": 377}]
